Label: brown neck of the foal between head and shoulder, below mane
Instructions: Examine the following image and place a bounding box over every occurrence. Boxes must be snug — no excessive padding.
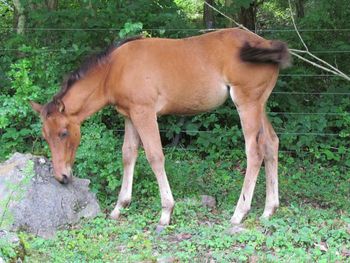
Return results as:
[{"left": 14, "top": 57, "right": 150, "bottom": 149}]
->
[{"left": 62, "top": 68, "right": 108, "bottom": 122}]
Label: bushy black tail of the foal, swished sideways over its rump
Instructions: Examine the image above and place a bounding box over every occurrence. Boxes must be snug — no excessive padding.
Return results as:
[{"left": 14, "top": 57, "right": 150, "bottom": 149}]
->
[{"left": 240, "top": 40, "right": 291, "bottom": 68}]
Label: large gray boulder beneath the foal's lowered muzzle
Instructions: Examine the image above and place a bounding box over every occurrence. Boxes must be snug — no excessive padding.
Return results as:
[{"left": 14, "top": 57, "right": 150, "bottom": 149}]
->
[{"left": 0, "top": 153, "right": 100, "bottom": 237}]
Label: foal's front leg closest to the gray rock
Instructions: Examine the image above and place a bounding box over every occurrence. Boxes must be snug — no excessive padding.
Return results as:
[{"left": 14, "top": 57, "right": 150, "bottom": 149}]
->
[{"left": 110, "top": 119, "right": 140, "bottom": 219}]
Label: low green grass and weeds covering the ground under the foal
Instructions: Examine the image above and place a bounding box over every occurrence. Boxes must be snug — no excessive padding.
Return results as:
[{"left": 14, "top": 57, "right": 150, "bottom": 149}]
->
[{"left": 0, "top": 155, "right": 350, "bottom": 262}]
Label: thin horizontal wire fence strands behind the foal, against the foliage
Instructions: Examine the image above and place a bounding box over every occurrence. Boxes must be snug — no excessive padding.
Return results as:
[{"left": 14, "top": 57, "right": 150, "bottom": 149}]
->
[{"left": 0, "top": 27, "right": 350, "bottom": 154}]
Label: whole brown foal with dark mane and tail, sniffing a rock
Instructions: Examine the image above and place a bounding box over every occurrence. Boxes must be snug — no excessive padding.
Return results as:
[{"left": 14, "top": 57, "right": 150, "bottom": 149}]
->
[{"left": 31, "top": 29, "right": 290, "bottom": 232}]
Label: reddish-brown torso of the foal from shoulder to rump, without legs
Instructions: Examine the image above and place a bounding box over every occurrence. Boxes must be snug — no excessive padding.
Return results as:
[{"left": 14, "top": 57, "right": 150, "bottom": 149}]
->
[{"left": 106, "top": 29, "right": 278, "bottom": 115}]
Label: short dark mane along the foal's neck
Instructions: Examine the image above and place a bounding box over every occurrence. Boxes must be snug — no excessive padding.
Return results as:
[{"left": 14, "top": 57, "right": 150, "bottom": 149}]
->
[{"left": 43, "top": 36, "right": 143, "bottom": 116}]
